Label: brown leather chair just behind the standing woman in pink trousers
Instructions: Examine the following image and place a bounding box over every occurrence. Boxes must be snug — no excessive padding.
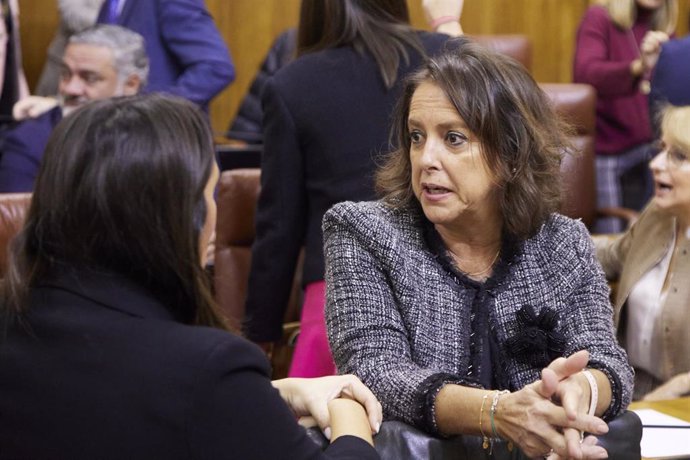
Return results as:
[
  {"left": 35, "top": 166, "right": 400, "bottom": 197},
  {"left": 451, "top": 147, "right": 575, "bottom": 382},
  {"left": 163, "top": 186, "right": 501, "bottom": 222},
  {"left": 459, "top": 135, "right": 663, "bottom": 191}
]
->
[{"left": 214, "top": 168, "right": 302, "bottom": 378}]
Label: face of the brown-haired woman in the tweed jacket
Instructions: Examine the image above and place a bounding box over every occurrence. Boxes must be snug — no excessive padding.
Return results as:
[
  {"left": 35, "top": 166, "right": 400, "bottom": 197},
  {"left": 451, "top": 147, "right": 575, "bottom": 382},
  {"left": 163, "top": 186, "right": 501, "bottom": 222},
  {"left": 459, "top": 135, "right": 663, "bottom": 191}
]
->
[{"left": 408, "top": 82, "right": 498, "bottom": 229}]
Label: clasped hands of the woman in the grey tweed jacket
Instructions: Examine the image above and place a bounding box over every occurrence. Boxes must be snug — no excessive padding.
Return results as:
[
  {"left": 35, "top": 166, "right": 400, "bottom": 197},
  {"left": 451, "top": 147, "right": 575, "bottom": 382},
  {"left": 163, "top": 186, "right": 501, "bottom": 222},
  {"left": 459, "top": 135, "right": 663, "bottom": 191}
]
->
[{"left": 497, "top": 351, "right": 608, "bottom": 459}]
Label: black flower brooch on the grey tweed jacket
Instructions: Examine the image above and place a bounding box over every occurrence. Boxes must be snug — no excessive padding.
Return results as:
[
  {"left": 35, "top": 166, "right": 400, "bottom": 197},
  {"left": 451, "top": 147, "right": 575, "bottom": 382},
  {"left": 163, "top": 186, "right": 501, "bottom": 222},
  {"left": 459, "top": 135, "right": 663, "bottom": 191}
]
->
[{"left": 506, "top": 305, "right": 566, "bottom": 368}]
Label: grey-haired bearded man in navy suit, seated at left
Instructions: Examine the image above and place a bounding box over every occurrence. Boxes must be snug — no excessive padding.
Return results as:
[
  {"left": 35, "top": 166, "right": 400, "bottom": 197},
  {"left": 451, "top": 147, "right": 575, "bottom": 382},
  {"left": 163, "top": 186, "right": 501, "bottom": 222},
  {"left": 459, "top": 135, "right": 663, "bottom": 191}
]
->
[{"left": 0, "top": 25, "right": 148, "bottom": 193}]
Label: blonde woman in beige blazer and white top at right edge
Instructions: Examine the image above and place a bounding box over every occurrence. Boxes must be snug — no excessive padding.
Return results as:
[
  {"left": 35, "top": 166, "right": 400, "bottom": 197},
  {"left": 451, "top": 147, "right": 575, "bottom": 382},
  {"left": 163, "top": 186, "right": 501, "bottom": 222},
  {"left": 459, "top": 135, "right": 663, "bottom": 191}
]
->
[{"left": 595, "top": 106, "right": 690, "bottom": 399}]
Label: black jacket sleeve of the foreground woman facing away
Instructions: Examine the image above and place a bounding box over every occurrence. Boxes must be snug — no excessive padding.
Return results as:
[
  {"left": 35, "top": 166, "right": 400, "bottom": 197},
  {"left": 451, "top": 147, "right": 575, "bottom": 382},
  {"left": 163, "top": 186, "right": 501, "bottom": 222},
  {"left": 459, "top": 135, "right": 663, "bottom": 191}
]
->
[{"left": 188, "top": 339, "right": 379, "bottom": 460}]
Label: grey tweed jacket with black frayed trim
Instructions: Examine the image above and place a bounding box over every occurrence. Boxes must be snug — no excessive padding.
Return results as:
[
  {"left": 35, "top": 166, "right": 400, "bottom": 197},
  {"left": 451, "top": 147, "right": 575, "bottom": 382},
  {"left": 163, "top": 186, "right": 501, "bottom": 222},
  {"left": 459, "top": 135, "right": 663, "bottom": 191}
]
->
[{"left": 323, "top": 202, "right": 633, "bottom": 432}]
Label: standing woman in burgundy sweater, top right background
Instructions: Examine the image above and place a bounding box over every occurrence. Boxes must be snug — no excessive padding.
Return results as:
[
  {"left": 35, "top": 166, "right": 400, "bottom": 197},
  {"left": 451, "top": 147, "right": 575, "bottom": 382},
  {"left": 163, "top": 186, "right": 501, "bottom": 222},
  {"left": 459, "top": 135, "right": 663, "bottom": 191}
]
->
[{"left": 573, "top": 0, "right": 678, "bottom": 233}]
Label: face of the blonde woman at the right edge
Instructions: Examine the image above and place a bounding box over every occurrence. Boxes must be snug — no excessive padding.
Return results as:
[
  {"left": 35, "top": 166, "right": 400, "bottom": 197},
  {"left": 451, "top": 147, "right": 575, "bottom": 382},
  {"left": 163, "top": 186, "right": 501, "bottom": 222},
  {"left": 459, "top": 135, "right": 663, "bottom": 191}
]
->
[{"left": 649, "top": 135, "right": 690, "bottom": 217}]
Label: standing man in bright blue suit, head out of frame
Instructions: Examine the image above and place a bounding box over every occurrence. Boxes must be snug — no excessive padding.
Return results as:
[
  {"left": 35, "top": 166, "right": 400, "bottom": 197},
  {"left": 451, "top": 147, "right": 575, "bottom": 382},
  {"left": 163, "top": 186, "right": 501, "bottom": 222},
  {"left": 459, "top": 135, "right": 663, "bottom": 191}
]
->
[{"left": 98, "top": 0, "right": 235, "bottom": 107}]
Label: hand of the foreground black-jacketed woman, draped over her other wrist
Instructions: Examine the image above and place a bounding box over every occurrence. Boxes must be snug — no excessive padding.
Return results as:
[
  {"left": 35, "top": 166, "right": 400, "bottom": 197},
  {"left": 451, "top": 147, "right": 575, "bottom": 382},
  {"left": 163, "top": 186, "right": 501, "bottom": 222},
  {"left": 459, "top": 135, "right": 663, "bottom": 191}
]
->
[{"left": 271, "top": 375, "right": 383, "bottom": 439}]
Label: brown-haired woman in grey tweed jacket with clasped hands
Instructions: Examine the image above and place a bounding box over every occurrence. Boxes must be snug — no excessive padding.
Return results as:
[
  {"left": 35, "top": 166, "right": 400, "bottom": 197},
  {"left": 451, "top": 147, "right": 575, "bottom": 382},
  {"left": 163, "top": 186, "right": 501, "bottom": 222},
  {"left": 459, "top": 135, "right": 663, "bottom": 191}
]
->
[{"left": 323, "top": 39, "right": 633, "bottom": 458}]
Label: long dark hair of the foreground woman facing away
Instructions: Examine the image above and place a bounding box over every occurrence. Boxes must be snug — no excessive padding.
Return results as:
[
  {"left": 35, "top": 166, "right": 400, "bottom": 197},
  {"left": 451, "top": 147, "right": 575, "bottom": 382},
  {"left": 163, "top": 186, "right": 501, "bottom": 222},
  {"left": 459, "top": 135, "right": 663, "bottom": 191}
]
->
[{"left": 3, "top": 95, "right": 220, "bottom": 325}]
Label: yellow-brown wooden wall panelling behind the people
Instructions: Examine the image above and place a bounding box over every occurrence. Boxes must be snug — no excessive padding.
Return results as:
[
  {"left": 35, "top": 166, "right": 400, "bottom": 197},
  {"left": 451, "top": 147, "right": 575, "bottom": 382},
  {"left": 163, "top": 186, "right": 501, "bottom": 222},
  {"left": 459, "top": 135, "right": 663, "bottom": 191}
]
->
[{"left": 14, "top": 0, "right": 690, "bottom": 133}]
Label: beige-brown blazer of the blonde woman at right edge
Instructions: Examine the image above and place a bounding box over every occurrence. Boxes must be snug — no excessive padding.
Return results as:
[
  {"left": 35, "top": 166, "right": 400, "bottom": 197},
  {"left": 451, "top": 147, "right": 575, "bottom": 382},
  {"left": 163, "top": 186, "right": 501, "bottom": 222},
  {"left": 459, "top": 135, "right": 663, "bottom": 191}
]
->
[{"left": 594, "top": 202, "right": 690, "bottom": 381}]
